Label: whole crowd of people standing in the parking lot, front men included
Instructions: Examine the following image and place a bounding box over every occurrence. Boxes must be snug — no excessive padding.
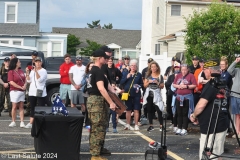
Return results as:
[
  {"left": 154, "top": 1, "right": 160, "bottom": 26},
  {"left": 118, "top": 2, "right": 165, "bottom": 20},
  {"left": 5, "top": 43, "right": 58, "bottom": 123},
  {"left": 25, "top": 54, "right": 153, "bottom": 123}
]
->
[{"left": 0, "top": 46, "right": 240, "bottom": 159}]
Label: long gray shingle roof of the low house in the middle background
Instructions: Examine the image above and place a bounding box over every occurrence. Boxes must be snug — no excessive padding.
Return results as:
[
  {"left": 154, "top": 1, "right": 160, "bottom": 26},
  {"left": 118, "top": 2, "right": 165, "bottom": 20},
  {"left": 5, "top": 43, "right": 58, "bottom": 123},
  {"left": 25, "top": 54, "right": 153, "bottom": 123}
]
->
[{"left": 52, "top": 27, "right": 141, "bottom": 48}]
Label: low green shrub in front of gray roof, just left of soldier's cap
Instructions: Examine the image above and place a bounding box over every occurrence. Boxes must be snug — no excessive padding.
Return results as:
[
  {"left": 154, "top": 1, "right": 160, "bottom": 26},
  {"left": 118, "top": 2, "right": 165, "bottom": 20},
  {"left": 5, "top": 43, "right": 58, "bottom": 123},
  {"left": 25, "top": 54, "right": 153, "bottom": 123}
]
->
[{"left": 80, "top": 40, "right": 102, "bottom": 56}]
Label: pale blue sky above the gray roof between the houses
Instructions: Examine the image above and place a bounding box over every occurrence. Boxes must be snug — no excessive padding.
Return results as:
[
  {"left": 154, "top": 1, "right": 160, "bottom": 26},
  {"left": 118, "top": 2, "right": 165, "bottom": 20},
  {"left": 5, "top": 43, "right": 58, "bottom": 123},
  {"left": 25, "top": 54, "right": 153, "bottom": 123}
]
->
[{"left": 40, "top": 0, "right": 142, "bottom": 32}]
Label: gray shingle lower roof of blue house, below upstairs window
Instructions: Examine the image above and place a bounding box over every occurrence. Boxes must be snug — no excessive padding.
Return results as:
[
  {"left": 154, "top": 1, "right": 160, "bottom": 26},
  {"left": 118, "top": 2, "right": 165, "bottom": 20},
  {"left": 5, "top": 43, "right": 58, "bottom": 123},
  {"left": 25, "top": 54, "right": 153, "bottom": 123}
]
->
[{"left": 0, "top": 23, "right": 40, "bottom": 36}]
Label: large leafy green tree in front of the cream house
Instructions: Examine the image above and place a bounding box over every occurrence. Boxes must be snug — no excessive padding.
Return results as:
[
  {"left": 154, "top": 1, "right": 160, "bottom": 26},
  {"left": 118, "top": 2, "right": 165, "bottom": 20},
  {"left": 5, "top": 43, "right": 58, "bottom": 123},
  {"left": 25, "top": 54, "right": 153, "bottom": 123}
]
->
[{"left": 185, "top": 3, "right": 240, "bottom": 63}]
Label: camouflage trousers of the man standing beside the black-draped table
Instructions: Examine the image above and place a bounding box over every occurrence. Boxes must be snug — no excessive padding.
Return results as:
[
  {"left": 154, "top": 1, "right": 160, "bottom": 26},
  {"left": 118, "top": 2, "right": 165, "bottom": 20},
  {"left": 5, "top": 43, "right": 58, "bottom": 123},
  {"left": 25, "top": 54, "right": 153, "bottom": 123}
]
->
[{"left": 87, "top": 95, "right": 108, "bottom": 156}]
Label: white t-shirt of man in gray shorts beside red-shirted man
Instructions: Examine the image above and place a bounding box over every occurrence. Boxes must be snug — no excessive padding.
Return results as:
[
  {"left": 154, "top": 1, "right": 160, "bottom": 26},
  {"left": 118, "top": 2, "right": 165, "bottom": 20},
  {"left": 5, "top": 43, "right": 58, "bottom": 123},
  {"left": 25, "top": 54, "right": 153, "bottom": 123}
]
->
[{"left": 69, "top": 65, "right": 86, "bottom": 90}]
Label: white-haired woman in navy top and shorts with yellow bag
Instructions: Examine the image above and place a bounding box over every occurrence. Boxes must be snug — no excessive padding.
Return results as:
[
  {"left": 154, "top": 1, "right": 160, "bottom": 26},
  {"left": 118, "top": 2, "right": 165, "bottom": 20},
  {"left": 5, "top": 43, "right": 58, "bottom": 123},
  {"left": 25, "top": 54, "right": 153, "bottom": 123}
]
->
[{"left": 120, "top": 59, "right": 143, "bottom": 130}]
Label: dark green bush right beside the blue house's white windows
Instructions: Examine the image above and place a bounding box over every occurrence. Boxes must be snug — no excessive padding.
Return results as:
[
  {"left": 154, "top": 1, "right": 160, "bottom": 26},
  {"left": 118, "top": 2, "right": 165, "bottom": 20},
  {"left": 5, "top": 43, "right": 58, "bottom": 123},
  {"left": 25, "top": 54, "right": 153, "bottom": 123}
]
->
[{"left": 67, "top": 34, "right": 81, "bottom": 56}]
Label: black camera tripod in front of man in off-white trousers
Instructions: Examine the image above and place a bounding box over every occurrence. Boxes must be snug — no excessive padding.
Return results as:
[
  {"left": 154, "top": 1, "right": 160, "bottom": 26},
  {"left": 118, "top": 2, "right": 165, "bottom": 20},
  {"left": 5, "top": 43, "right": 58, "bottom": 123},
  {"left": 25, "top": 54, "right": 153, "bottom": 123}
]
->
[{"left": 201, "top": 93, "right": 240, "bottom": 160}]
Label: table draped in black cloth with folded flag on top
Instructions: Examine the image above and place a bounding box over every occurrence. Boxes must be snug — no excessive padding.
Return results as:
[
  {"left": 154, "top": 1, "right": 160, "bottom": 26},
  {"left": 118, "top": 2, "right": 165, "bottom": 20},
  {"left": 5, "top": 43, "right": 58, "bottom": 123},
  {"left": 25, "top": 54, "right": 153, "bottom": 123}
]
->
[{"left": 31, "top": 106, "right": 84, "bottom": 160}]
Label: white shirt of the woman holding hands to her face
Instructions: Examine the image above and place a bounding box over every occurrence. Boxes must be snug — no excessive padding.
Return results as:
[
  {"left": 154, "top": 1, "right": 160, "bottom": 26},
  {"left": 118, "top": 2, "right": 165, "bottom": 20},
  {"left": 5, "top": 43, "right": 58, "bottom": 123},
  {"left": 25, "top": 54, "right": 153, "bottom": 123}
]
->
[{"left": 27, "top": 68, "right": 47, "bottom": 97}]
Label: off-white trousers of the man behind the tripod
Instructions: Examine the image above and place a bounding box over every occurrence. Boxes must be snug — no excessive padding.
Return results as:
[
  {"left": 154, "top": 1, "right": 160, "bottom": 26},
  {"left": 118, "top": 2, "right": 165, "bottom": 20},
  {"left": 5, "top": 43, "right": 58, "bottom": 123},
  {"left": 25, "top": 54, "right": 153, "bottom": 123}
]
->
[{"left": 199, "top": 129, "right": 227, "bottom": 160}]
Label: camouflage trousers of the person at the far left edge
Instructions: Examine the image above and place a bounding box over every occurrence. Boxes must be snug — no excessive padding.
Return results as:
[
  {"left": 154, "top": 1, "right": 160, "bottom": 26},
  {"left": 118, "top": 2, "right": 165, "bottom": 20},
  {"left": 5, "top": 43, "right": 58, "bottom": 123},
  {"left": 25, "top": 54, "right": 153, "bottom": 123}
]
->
[{"left": 0, "top": 85, "right": 12, "bottom": 113}]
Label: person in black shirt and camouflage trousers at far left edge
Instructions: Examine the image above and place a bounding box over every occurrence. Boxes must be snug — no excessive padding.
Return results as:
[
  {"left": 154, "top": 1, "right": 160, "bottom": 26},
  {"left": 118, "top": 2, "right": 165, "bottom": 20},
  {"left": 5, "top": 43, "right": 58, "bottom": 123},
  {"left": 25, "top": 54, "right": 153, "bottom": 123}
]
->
[{"left": 0, "top": 57, "right": 12, "bottom": 116}]
